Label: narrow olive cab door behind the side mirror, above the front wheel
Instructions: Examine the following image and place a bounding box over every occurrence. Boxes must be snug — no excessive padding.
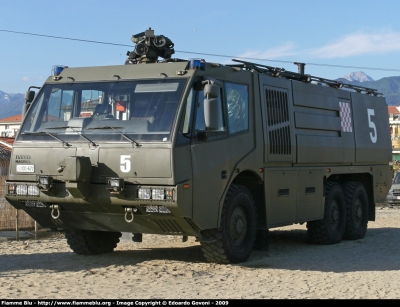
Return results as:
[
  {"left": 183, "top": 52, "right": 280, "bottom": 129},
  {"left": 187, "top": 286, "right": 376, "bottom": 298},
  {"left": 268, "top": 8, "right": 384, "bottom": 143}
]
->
[{"left": 191, "top": 83, "right": 230, "bottom": 229}]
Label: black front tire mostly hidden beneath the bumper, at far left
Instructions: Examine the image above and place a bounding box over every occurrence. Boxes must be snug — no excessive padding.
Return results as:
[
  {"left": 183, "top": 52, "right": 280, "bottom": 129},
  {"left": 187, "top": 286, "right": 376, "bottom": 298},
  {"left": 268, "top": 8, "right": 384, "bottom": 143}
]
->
[{"left": 65, "top": 229, "right": 122, "bottom": 255}]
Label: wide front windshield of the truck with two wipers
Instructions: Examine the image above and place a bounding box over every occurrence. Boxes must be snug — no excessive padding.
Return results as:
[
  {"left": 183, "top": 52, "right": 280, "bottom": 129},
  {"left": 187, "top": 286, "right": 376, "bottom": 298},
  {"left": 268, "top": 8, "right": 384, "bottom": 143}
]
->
[{"left": 20, "top": 79, "right": 185, "bottom": 142}]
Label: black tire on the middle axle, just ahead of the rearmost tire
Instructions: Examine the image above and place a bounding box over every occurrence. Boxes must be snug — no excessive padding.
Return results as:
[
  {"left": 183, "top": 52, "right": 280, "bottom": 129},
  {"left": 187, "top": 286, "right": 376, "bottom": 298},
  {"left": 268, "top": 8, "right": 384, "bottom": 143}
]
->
[{"left": 307, "top": 182, "right": 346, "bottom": 244}]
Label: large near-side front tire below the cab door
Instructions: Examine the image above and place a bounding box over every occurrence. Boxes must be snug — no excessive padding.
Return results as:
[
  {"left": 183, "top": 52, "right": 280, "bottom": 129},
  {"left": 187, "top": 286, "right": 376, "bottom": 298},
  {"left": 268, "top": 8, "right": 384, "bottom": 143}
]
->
[{"left": 201, "top": 184, "right": 257, "bottom": 263}]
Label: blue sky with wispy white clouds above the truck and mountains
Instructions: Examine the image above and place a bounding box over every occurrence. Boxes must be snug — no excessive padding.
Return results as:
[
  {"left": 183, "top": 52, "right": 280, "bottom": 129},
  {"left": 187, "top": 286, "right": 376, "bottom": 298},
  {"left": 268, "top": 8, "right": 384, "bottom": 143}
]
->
[{"left": 0, "top": 0, "right": 400, "bottom": 94}]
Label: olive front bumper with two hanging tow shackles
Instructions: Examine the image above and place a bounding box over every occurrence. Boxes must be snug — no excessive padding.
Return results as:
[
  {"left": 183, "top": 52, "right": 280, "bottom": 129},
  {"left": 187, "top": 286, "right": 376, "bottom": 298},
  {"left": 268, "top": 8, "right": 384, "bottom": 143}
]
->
[{"left": 6, "top": 181, "right": 199, "bottom": 236}]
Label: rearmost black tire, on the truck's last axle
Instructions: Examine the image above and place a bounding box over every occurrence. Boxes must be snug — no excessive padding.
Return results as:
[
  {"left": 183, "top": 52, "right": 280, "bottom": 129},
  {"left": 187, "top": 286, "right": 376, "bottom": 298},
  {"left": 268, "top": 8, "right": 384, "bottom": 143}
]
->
[{"left": 343, "top": 182, "right": 368, "bottom": 240}]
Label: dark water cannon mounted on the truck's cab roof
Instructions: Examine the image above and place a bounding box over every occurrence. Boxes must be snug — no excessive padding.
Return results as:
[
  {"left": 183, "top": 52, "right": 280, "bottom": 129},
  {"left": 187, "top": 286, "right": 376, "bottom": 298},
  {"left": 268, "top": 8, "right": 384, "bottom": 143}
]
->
[{"left": 125, "top": 28, "right": 175, "bottom": 64}]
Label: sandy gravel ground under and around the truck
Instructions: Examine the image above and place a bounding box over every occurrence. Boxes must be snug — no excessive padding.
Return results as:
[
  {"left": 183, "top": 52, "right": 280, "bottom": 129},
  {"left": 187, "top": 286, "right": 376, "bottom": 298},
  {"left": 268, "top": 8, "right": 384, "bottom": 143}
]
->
[{"left": 0, "top": 205, "right": 400, "bottom": 299}]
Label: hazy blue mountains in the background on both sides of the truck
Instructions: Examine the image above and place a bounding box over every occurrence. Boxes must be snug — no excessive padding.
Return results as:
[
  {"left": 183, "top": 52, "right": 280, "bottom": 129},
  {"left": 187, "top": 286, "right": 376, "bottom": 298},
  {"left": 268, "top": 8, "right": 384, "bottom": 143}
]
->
[{"left": 0, "top": 71, "right": 400, "bottom": 119}]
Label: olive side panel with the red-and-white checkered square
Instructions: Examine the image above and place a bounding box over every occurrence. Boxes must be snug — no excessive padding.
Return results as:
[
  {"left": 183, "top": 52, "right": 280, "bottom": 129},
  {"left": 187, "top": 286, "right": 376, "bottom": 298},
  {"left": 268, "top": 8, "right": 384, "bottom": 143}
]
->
[{"left": 292, "top": 81, "right": 355, "bottom": 163}]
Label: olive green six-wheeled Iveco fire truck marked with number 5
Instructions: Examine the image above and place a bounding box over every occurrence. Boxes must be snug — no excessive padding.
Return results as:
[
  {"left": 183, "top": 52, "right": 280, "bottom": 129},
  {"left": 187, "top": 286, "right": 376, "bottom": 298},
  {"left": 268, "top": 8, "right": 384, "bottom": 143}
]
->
[{"left": 5, "top": 29, "right": 393, "bottom": 263}]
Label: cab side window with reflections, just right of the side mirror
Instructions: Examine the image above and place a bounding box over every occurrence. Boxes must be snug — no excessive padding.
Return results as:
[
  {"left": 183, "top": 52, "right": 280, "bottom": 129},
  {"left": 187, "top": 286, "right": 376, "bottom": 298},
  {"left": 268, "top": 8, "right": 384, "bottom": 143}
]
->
[{"left": 225, "top": 82, "right": 249, "bottom": 134}]
